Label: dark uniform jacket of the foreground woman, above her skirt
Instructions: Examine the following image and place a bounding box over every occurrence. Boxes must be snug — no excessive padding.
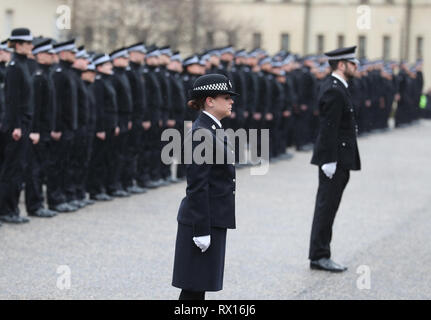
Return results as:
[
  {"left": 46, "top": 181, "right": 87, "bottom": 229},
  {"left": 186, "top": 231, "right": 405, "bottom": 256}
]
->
[{"left": 178, "top": 113, "right": 236, "bottom": 237}]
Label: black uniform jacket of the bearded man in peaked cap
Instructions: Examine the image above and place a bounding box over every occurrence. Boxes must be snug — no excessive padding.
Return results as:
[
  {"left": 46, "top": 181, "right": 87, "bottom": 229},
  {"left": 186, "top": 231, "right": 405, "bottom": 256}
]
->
[{"left": 311, "top": 76, "right": 361, "bottom": 170}]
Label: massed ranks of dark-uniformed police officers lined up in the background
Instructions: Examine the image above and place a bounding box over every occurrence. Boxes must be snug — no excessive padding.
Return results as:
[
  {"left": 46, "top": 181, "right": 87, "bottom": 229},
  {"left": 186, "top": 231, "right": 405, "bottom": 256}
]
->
[{"left": 0, "top": 28, "right": 423, "bottom": 223}]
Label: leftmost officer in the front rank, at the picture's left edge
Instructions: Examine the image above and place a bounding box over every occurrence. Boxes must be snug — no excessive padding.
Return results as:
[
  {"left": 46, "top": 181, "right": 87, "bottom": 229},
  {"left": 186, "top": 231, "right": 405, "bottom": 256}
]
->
[{"left": 0, "top": 28, "right": 34, "bottom": 224}]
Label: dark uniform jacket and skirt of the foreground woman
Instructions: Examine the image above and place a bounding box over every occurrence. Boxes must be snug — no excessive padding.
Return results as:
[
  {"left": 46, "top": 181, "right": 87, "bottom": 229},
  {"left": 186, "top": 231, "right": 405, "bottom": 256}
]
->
[{"left": 172, "top": 113, "right": 236, "bottom": 291}]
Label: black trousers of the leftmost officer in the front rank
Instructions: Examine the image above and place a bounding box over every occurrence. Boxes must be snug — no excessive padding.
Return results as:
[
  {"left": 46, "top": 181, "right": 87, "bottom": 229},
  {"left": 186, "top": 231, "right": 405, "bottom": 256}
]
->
[{"left": 0, "top": 127, "right": 30, "bottom": 215}]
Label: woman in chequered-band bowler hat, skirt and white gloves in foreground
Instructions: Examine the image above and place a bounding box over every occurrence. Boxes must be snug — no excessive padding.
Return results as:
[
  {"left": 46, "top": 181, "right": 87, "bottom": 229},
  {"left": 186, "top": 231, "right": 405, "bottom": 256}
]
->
[{"left": 172, "top": 74, "right": 237, "bottom": 300}]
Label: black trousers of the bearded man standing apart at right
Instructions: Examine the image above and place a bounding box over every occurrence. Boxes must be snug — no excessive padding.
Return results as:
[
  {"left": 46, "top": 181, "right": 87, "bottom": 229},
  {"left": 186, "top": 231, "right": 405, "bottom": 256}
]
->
[{"left": 309, "top": 167, "right": 350, "bottom": 261}]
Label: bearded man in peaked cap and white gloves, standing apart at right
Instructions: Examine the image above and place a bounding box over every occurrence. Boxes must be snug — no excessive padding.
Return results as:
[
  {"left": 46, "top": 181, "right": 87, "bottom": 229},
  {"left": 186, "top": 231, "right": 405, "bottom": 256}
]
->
[{"left": 309, "top": 46, "right": 361, "bottom": 272}]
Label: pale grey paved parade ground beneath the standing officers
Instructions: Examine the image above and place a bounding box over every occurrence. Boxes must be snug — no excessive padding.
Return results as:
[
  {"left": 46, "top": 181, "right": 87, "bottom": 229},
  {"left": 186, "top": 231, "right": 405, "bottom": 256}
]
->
[{"left": 0, "top": 121, "right": 431, "bottom": 300}]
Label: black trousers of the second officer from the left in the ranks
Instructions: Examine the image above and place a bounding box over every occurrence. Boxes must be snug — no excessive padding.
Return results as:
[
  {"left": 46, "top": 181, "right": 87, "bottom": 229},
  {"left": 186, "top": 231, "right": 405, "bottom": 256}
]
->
[{"left": 25, "top": 140, "right": 49, "bottom": 214}]
